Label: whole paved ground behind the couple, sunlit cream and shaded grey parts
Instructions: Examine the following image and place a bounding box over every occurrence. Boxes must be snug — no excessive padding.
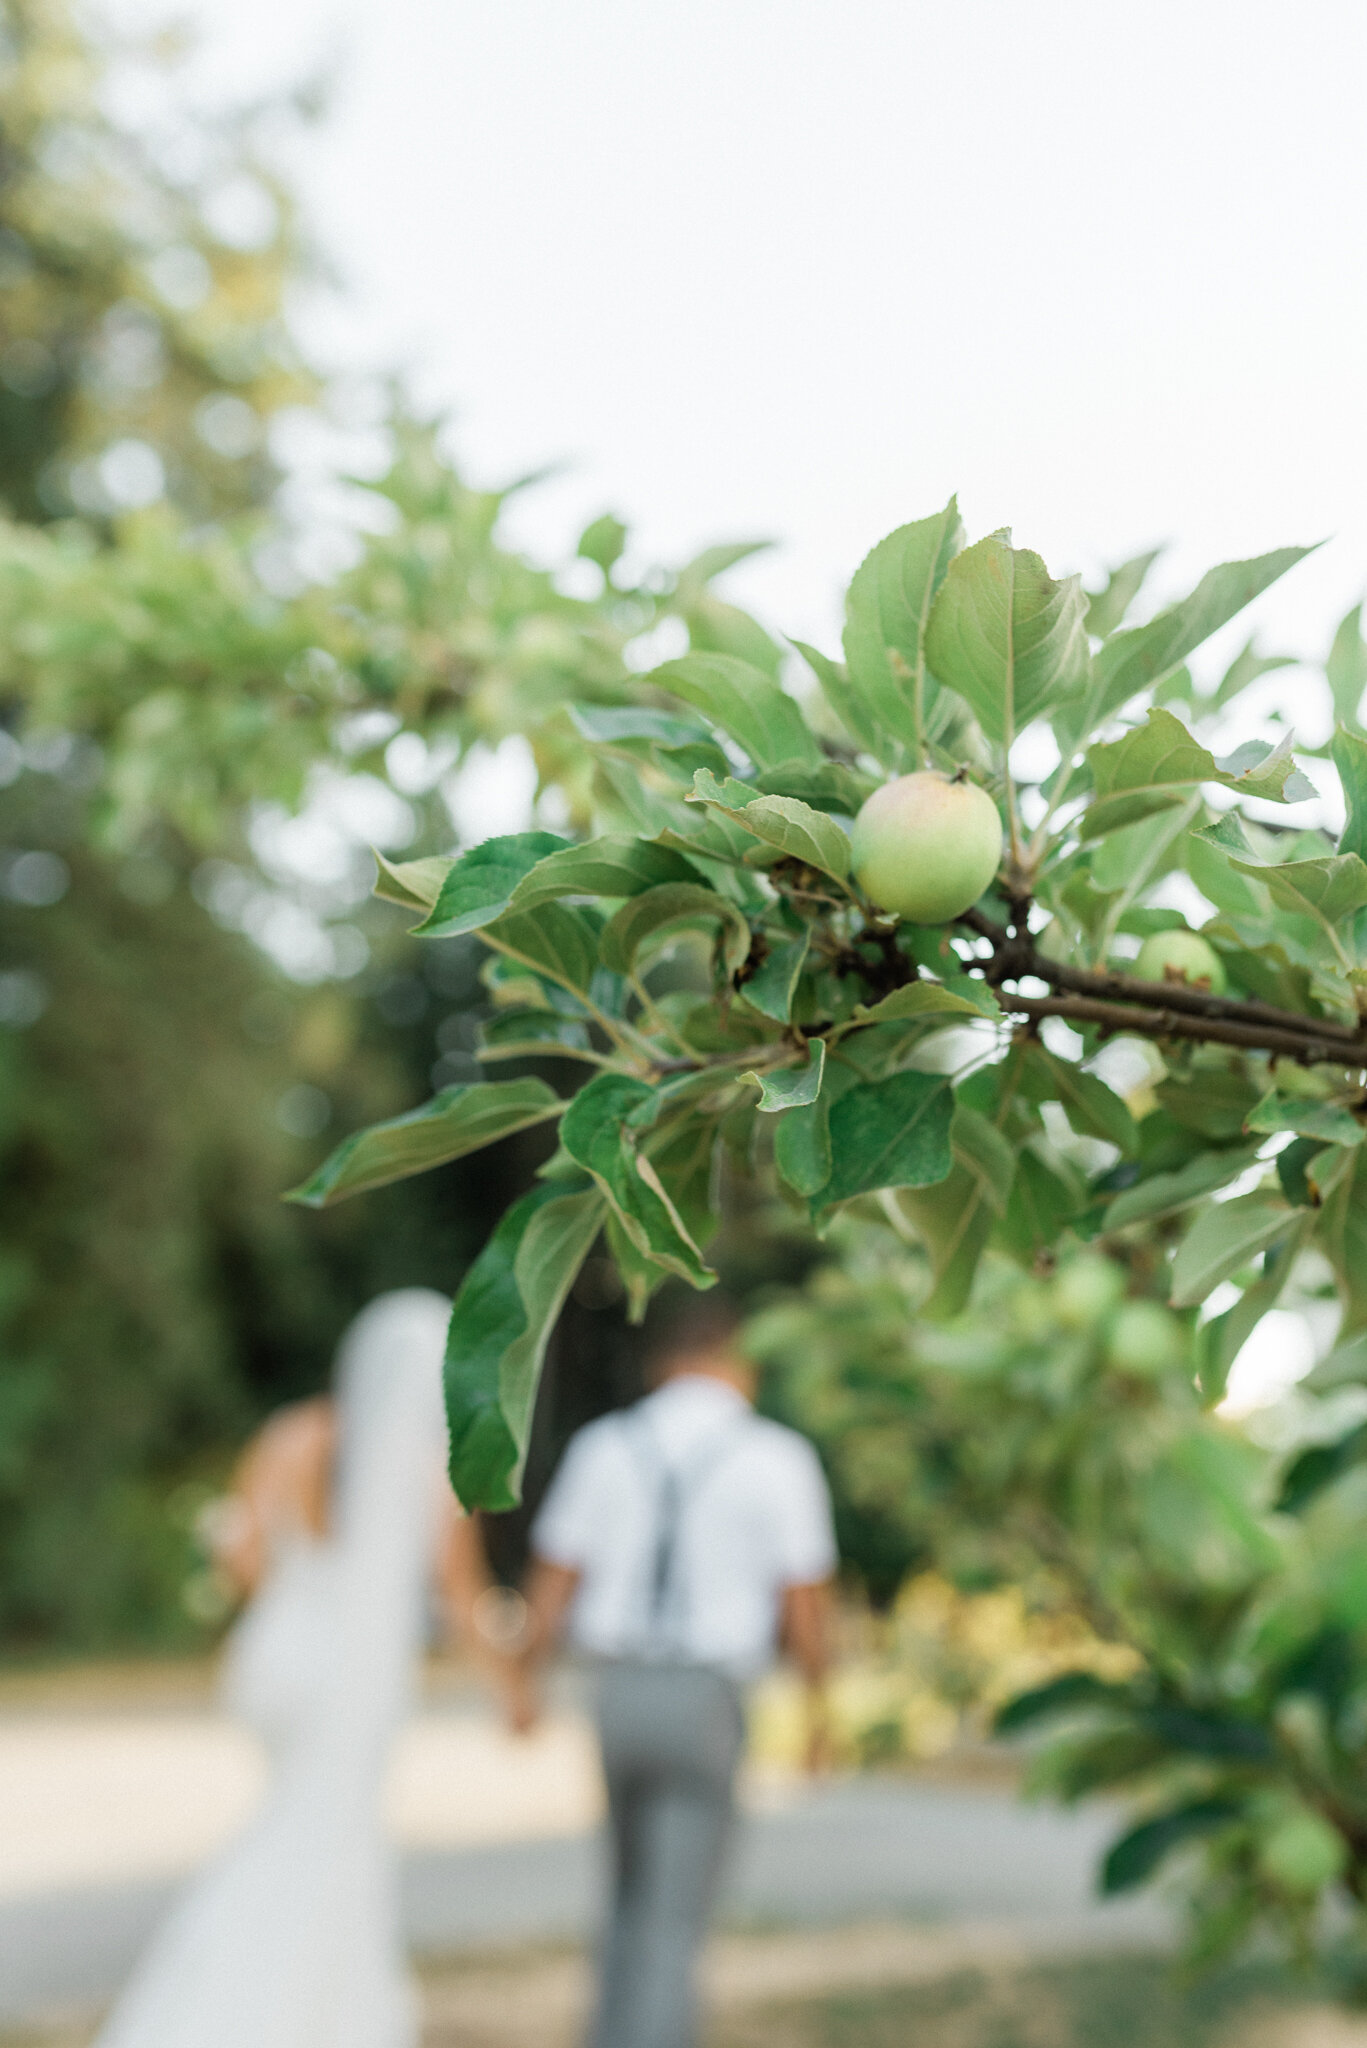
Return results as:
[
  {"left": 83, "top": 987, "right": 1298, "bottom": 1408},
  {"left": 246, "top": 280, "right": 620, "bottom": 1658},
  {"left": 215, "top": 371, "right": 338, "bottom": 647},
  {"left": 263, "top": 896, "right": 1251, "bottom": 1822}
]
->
[{"left": 0, "top": 1667, "right": 1168, "bottom": 2025}]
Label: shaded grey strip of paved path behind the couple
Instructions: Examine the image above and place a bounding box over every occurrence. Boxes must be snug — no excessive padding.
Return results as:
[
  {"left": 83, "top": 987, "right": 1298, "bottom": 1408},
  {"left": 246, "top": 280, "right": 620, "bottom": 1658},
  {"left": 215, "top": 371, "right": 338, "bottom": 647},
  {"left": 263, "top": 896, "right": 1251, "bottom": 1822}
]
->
[{"left": 0, "top": 1778, "right": 1168, "bottom": 2023}]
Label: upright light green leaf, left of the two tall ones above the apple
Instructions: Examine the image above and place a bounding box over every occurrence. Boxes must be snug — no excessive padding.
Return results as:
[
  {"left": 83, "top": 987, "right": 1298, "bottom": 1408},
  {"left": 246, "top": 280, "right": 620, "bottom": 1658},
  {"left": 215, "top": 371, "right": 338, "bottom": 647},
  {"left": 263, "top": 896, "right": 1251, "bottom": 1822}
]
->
[{"left": 840, "top": 498, "right": 963, "bottom": 768}]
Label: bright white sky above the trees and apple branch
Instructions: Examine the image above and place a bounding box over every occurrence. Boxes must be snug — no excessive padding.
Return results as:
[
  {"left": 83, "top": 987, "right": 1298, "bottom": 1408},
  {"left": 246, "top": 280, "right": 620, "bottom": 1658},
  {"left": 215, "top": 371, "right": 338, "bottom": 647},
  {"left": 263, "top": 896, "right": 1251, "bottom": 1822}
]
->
[{"left": 119, "top": 0, "right": 1367, "bottom": 671}]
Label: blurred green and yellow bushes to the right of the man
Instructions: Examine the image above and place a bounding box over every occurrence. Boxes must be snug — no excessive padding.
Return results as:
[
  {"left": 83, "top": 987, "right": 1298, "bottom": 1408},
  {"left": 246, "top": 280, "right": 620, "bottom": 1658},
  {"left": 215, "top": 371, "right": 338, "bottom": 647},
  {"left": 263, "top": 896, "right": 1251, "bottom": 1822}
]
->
[{"left": 750, "top": 1219, "right": 1367, "bottom": 1991}]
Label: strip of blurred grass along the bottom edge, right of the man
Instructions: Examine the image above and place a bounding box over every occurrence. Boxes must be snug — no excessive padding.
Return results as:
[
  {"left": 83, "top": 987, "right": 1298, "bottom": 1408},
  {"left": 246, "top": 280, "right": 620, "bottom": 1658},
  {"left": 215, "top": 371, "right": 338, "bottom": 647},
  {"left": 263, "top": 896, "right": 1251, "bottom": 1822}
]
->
[{"left": 709, "top": 1956, "right": 1344, "bottom": 2048}]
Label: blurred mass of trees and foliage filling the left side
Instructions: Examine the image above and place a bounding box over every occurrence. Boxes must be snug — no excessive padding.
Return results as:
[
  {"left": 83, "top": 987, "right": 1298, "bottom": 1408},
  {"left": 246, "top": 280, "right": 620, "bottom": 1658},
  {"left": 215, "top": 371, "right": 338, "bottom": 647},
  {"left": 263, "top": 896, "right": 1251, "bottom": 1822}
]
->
[{"left": 0, "top": 0, "right": 791, "bottom": 1657}]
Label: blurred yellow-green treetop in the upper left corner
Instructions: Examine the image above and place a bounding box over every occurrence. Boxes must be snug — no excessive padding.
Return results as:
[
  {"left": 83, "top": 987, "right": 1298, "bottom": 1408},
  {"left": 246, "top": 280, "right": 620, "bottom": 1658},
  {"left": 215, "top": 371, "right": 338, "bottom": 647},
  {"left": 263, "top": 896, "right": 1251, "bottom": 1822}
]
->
[{"left": 0, "top": 0, "right": 318, "bottom": 520}]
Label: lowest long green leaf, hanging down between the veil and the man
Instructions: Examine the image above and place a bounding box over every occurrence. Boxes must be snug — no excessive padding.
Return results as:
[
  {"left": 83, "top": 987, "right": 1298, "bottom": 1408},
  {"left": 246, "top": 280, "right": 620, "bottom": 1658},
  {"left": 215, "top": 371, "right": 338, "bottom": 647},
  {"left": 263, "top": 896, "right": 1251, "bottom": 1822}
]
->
[{"left": 445, "top": 1180, "right": 605, "bottom": 1511}]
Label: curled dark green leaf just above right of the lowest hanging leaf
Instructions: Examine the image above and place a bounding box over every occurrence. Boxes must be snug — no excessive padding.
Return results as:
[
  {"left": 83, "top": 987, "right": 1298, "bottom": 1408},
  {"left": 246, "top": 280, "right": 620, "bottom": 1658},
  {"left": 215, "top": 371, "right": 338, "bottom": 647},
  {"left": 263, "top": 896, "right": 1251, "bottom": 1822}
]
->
[{"left": 560, "top": 1073, "right": 717, "bottom": 1286}]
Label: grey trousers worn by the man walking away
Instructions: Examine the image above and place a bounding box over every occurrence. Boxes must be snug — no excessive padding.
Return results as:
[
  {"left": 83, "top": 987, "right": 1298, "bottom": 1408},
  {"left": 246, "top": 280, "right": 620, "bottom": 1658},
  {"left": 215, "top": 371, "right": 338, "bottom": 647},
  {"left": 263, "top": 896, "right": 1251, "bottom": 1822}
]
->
[{"left": 588, "top": 1663, "right": 744, "bottom": 2048}]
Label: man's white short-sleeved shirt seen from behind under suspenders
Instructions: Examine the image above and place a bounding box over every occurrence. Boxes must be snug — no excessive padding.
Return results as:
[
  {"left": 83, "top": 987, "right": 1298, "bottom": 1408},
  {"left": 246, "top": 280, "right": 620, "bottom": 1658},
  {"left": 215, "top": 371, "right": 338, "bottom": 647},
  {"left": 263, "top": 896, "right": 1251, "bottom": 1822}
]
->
[{"left": 531, "top": 1374, "right": 836, "bottom": 1679}]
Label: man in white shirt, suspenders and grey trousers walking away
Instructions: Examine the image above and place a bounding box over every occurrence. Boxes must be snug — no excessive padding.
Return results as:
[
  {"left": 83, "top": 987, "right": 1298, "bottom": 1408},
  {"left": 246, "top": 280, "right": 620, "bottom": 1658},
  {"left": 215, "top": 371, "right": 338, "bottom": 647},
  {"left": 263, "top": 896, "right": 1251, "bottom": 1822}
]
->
[{"left": 510, "top": 1296, "right": 836, "bottom": 2048}]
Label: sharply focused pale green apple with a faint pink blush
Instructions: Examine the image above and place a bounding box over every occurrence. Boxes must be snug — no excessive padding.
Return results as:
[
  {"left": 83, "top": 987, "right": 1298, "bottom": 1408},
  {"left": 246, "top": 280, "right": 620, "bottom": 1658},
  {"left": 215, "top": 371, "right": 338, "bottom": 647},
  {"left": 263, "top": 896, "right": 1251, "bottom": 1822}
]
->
[{"left": 851, "top": 768, "right": 1002, "bottom": 924}]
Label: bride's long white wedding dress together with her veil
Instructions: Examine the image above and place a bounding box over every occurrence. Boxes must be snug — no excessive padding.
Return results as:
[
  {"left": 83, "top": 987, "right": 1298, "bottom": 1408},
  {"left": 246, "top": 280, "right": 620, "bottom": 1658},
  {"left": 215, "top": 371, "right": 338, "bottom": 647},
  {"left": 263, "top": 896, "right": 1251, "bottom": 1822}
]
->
[{"left": 96, "top": 1288, "right": 451, "bottom": 2048}]
